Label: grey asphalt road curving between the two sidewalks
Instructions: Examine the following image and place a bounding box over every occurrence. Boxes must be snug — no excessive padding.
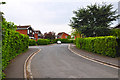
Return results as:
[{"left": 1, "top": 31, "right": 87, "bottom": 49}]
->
[{"left": 31, "top": 44, "right": 118, "bottom": 78}]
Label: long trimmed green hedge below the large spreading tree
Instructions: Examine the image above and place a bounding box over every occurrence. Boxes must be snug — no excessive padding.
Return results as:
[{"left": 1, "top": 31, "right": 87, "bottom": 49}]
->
[{"left": 76, "top": 36, "right": 120, "bottom": 57}]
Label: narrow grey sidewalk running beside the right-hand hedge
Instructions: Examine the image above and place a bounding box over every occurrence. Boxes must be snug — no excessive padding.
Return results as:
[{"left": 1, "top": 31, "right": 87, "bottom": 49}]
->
[{"left": 70, "top": 44, "right": 120, "bottom": 66}]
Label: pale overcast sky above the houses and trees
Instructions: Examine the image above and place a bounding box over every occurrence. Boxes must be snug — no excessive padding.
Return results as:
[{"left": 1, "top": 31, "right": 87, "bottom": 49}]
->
[{"left": 0, "top": 0, "right": 118, "bottom": 34}]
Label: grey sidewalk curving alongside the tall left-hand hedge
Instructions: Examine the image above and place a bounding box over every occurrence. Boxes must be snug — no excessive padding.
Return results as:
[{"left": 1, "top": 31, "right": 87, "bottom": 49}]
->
[{"left": 4, "top": 48, "right": 38, "bottom": 79}]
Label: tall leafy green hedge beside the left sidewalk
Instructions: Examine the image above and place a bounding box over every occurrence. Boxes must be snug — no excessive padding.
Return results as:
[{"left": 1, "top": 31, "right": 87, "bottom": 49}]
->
[{"left": 2, "top": 30, "right": 29, "bottom": 70}]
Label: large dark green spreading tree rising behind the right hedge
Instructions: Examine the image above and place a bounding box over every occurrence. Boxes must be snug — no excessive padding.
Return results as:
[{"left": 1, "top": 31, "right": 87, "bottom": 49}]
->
[{"left": 70, "top": 3, "right": 119, "bottom": 37}]
